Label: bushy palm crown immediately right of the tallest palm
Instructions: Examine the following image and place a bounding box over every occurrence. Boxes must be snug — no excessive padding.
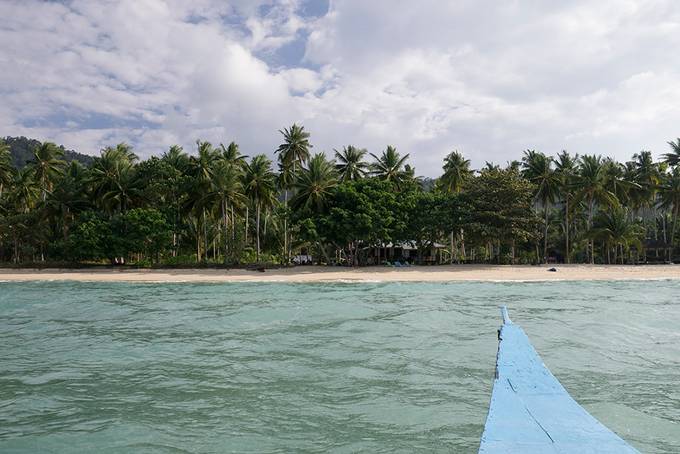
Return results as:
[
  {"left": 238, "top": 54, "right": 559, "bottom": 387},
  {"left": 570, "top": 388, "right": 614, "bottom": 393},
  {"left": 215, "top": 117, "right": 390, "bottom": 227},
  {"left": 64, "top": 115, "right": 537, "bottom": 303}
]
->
[{"left": 291, "top": 153, "right": 338, "bottom": 211}]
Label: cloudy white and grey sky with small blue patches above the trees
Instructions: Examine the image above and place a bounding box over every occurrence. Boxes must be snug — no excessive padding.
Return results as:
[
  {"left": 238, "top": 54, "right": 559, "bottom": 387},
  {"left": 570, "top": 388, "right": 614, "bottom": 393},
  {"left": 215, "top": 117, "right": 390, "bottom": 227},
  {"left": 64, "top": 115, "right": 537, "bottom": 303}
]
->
[{"left": 0, "top": 0, "right": 680, "bottom": 177}]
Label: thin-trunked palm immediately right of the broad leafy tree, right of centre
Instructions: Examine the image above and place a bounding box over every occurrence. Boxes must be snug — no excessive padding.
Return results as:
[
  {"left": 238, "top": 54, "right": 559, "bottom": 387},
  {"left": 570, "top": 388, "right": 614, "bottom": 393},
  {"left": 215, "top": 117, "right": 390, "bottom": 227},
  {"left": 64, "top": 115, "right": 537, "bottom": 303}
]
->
[{"left": 522, "top": 150, "right": 561, "bottom": 262}]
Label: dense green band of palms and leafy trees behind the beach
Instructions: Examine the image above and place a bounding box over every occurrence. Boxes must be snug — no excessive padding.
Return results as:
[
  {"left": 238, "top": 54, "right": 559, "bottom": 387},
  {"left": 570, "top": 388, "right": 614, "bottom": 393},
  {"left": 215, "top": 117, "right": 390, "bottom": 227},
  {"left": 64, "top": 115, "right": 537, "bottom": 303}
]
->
[{"left": 0, "top": 124, "right": 680, "bottom": 266}]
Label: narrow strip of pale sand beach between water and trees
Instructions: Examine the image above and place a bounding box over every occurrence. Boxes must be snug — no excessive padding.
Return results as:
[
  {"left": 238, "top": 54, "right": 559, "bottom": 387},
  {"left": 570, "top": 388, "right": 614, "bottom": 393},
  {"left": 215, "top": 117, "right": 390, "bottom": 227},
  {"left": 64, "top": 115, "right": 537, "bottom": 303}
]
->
[{"left": 0, "top": 264, "right": 680, "bottom": 283}]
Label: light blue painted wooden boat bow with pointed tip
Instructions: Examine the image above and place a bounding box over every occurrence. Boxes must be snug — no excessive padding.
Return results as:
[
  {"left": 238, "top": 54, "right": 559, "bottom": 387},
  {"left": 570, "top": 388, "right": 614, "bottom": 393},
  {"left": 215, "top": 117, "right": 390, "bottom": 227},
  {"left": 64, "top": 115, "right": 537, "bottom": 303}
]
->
[{"left": 479, "top": 307, "right": 638, "bottom": 454}]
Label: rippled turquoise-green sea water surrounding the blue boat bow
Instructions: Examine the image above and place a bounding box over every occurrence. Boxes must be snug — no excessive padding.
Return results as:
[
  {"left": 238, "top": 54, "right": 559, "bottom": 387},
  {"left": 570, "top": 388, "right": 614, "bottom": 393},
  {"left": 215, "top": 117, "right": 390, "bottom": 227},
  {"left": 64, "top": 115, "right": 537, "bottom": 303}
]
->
[{"left": 0, "top": 281, "right": 680, "bottom": 453}]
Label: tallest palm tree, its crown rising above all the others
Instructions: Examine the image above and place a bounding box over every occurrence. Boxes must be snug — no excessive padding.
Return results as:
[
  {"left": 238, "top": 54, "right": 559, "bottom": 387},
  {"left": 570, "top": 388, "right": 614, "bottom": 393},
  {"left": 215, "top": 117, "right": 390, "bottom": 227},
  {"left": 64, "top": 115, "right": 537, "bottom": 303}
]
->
[{"left": 274, "top": 123, "right": 313, "bottom": 261}]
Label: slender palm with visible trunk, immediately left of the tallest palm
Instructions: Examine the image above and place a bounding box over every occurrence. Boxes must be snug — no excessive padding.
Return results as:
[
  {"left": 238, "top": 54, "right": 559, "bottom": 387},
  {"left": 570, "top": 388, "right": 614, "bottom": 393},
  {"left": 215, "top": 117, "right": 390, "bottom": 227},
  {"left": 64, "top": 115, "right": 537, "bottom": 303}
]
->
[{"left": 243, "top": 155, "right": 276, "bottom": 262}]
